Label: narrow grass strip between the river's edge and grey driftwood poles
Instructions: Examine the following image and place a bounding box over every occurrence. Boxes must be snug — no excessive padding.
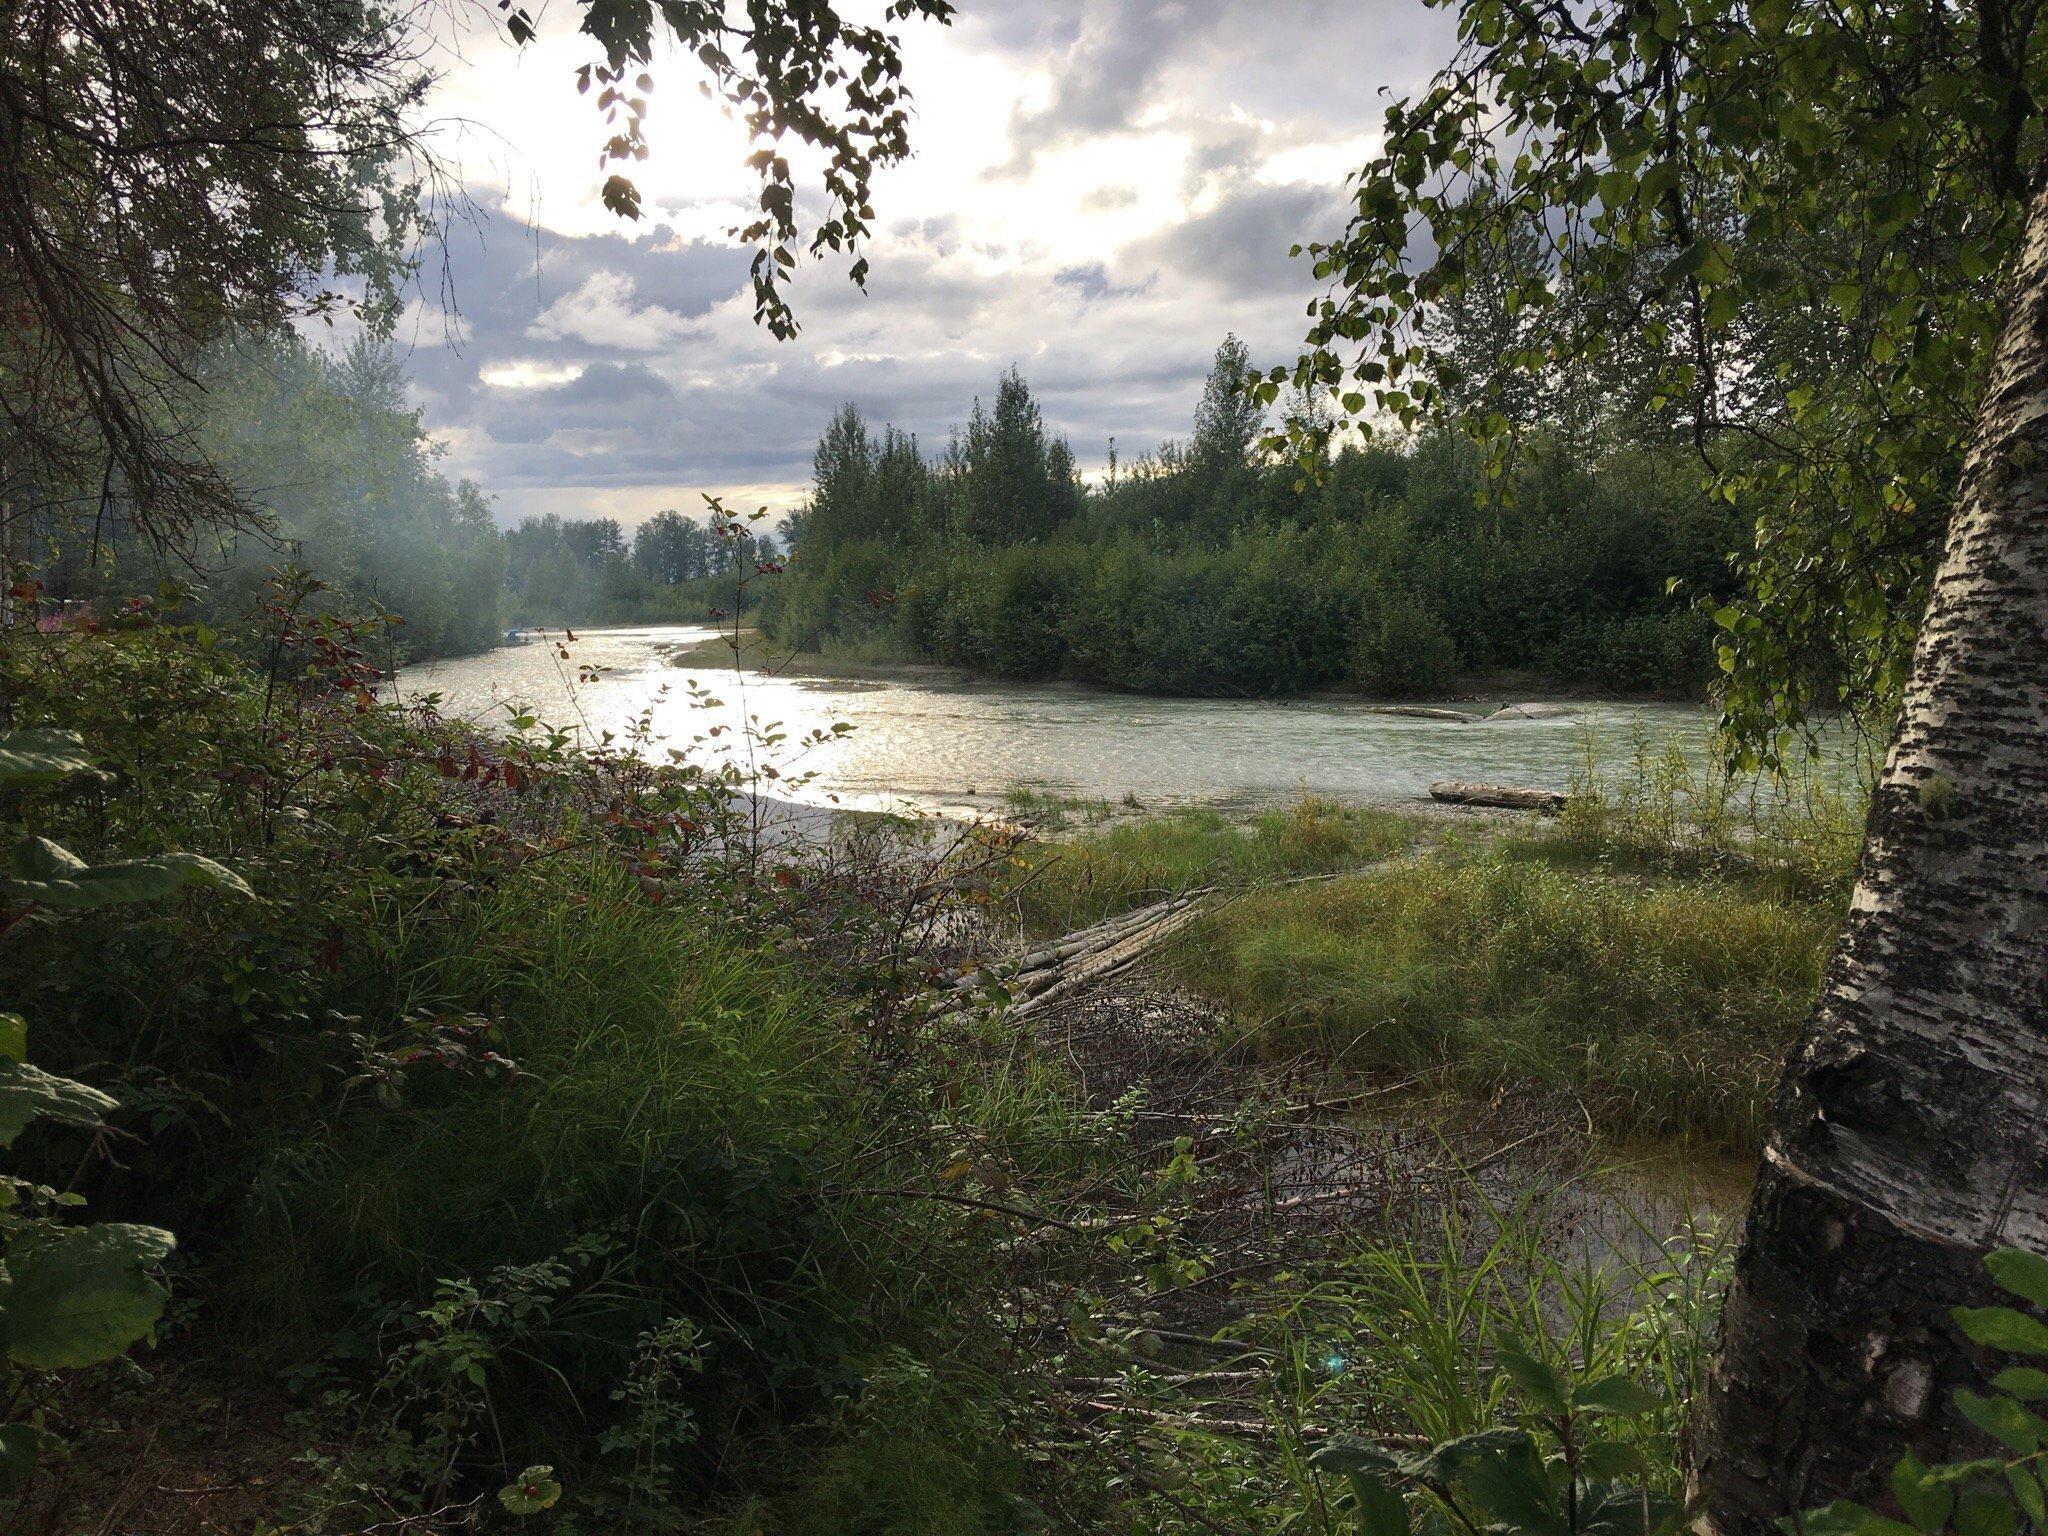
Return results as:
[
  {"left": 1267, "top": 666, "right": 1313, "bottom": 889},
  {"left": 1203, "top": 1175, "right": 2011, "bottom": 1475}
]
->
[{"left": 1016, "top": 797, "right": 1419, "bottom": 934}]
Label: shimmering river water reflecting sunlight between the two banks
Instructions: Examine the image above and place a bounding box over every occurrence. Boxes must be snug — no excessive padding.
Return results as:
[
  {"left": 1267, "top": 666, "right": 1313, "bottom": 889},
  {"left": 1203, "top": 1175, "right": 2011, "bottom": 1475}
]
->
[{"left": 397, "top": 625, "right": 1708, "bottom": 811}]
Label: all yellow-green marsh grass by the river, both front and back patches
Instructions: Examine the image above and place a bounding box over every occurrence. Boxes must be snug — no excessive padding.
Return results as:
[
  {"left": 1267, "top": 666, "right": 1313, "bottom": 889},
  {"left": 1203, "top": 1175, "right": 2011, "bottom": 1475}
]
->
[{"left": 1012, "top": 801, "right": 1845, "bottom": 1151}]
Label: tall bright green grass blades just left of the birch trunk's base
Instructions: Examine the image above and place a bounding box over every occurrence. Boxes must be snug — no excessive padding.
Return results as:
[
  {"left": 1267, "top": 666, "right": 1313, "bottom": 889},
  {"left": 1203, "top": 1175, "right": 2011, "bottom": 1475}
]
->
[{"left": 1114, "top": 1186, "right": 1733, "bottom": 1536}]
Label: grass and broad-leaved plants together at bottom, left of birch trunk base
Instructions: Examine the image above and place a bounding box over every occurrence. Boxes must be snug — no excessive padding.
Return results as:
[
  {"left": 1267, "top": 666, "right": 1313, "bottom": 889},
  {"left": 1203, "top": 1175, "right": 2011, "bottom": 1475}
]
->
[{"left": 1089, "top": 1204, "right": 1731, "bottom": 1536}]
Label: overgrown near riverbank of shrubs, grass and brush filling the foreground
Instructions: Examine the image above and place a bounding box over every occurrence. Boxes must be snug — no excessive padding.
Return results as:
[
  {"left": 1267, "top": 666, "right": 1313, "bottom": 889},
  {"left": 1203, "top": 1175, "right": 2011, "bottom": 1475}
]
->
[{"left": 0, "top": 606, "right": 1843, "bottom": 1536}]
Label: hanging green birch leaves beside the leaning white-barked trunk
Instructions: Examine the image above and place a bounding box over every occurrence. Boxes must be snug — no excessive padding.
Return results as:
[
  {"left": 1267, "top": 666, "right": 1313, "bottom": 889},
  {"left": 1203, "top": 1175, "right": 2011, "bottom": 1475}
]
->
[{"left": 1264, "top": 0, "right": 2048, "bottom": 762}]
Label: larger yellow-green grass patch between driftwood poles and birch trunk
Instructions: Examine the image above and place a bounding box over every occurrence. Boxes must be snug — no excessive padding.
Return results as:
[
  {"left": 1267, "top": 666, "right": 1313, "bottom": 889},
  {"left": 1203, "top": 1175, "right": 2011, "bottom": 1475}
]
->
[{"left": 1171, "top": 846, "right": 1837, "bottom": 1151}]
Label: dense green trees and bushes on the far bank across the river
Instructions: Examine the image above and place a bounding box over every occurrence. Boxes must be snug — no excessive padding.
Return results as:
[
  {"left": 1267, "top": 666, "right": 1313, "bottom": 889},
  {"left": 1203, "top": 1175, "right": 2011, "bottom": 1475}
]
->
[{"left": 762, "top": 337, "right": 1741, "bottom": 694}]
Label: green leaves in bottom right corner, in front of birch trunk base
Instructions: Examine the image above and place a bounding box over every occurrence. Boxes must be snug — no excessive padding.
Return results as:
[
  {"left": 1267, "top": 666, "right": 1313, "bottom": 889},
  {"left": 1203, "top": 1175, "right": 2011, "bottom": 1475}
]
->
[{"left": 1780, "top": 1247, "right": 2048, "bottom": 1536}]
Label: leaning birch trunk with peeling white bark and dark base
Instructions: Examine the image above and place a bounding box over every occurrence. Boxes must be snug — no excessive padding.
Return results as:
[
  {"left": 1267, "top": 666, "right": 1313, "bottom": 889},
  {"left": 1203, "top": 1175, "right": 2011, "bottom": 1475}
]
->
[{"left": 1694, "top": 177, "right": 2048, "bottom": 1536}]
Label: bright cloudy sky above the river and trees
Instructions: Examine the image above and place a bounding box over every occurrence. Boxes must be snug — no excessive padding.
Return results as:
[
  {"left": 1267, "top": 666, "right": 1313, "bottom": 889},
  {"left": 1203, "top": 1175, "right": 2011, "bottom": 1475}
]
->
[{"left": 401, "top": 0, "right": 1452, "bottom": 524}]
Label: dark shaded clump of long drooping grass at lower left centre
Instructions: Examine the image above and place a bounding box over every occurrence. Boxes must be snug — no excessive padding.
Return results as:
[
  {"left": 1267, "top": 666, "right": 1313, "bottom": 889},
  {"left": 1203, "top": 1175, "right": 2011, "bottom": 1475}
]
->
[{"left": 223, "top": 868, "right": 1073, "bottom": 1536}]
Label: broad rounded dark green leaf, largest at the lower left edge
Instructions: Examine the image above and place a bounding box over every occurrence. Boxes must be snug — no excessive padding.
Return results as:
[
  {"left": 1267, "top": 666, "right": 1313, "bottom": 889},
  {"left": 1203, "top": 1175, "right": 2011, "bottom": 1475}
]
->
[{"left": 0, "top": 1223, "right": 176, "bottom": 1368}]
